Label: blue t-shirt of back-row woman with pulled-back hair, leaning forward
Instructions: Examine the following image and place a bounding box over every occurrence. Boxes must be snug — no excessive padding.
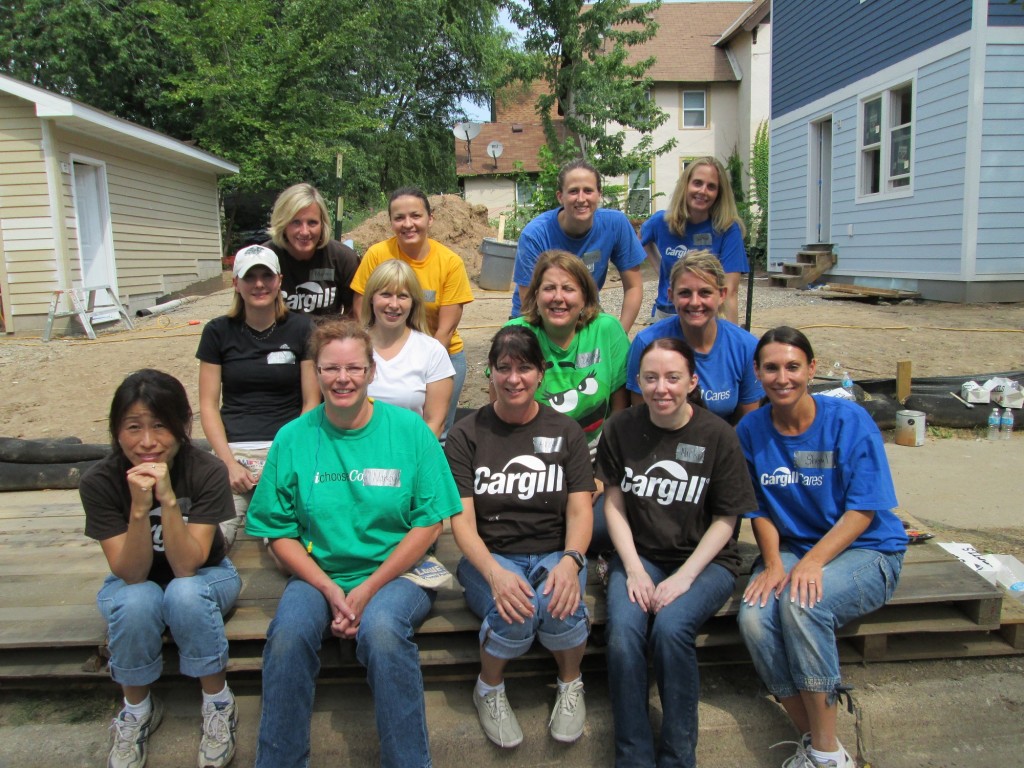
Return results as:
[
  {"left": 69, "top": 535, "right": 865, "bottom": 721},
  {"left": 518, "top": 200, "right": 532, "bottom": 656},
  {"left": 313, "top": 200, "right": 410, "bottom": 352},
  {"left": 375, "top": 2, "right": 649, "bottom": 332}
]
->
[{"left": 512, "top": 208, "right": 647, "bottom": 317}]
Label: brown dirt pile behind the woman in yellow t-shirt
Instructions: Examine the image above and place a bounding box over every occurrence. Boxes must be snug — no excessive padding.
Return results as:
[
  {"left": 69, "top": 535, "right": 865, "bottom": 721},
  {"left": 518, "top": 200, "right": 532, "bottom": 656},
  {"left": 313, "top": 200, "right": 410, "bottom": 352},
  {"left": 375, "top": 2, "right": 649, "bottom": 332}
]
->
[{"left": 342, "top": 195, "right": 498, "bottom": 283}]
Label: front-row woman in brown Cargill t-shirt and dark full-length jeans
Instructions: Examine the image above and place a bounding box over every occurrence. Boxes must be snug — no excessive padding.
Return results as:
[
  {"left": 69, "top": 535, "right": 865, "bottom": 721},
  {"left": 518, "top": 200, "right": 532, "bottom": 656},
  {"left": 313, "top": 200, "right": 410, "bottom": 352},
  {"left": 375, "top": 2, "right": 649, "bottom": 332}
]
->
[{"left": 597, "top": 339, "right": 757, "bottom": 768}]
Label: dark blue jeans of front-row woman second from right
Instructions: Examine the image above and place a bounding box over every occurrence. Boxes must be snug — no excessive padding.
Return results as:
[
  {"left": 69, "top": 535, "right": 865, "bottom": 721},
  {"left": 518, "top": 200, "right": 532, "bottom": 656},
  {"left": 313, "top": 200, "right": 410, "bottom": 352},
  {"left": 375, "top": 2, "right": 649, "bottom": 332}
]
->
[{"left": 606, "top": 555, "right": 736, "bottom": 768}]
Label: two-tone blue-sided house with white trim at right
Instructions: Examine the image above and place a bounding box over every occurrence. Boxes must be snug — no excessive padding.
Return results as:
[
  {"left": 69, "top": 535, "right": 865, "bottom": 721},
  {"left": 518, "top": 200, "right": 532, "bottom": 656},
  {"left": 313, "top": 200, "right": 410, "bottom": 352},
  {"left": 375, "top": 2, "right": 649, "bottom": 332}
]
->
[{"left": 768, "top": 0, "right": 1024, "bottom": 301}]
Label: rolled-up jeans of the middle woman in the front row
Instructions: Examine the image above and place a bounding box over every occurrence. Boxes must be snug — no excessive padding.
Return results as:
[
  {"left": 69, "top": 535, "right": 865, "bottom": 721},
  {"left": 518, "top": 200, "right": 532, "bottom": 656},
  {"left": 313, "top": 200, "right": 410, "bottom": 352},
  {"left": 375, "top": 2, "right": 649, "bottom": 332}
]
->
[{"left": 456, "top": 550, "right": 590, "bottom": 658}]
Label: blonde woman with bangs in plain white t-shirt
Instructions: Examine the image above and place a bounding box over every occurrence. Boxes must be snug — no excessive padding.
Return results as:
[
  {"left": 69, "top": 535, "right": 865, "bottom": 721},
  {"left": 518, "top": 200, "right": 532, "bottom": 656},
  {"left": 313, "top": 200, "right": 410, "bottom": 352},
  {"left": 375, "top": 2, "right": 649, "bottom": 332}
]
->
[{"left": 364, "top": 259, "right": 455, "bottom": 437}]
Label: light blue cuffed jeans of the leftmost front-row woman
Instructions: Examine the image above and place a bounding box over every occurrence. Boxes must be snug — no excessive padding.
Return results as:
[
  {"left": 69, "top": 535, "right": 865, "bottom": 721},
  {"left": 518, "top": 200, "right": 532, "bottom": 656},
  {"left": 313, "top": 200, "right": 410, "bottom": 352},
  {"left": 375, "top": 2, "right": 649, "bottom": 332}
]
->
[{"left": 96, "top": 557, "right": 242, "bottom": 685}]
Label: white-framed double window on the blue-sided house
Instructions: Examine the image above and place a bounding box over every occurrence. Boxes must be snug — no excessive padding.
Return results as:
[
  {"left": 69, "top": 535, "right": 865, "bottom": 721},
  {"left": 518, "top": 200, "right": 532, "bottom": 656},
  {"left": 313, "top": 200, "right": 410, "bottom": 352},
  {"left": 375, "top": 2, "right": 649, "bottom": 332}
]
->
[{"left": 856, "top": 78, "right": 918, "bottom": 203}]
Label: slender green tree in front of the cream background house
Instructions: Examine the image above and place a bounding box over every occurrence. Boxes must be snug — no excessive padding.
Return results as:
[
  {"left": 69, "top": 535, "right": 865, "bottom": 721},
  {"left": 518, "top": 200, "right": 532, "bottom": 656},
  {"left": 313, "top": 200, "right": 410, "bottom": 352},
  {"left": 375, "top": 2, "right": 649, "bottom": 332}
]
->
[{"left": 504, "top": 0, "right": 675, "bottom": 176}]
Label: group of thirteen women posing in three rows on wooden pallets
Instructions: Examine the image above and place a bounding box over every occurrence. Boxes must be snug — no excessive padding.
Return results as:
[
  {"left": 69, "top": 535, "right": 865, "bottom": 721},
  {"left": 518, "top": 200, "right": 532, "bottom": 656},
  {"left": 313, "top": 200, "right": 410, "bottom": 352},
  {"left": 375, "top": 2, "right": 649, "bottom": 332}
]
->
[{"left": 81, "top": 161, "right": 906, "bottom": 768}]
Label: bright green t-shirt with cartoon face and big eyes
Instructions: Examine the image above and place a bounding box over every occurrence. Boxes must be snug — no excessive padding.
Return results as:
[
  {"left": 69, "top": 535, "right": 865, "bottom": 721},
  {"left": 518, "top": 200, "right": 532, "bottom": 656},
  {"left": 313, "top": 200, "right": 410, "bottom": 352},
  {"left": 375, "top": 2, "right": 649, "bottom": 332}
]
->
[{"left": 505, "top": 312, "right": 630, "bottom": 456}]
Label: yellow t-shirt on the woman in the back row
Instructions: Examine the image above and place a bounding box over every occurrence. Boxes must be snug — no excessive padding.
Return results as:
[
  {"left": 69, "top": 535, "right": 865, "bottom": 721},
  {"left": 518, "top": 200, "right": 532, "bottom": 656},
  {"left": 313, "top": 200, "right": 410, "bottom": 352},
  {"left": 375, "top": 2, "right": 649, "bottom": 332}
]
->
[{"left": 352, "top": 238, "right": 473, "bottom": 354}]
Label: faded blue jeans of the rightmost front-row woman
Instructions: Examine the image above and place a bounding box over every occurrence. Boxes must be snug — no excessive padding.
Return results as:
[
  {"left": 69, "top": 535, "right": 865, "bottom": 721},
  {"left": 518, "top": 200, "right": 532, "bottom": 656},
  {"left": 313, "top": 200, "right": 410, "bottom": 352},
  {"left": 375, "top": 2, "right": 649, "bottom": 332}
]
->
[{"left": 738, "top": 549, "right": 903, "bottom": 706}]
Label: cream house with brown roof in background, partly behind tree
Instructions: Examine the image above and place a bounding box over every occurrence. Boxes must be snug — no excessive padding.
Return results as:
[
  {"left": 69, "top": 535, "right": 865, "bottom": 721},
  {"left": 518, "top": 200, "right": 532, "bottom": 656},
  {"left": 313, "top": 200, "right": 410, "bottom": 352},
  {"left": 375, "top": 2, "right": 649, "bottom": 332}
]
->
[{"left": 456, "top": 0, "right": 771, "bottom": 217}]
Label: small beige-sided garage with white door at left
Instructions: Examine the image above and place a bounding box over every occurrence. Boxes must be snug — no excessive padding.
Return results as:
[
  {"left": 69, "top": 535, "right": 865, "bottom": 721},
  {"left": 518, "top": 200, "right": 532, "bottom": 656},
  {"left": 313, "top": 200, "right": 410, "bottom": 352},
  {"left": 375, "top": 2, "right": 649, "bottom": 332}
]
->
[{"left": 0, "top": 75, "right": 239, "bottom": 334}]
